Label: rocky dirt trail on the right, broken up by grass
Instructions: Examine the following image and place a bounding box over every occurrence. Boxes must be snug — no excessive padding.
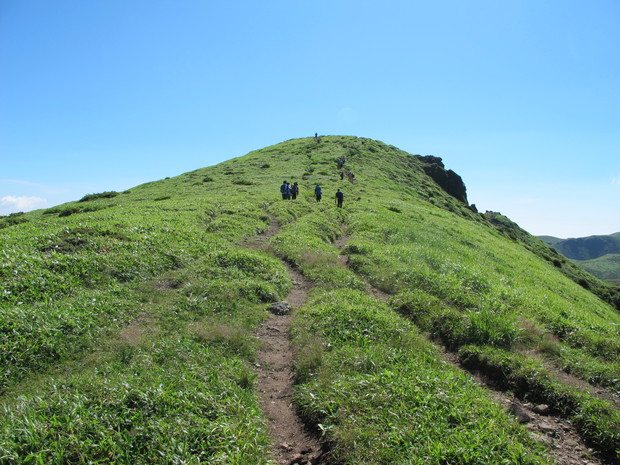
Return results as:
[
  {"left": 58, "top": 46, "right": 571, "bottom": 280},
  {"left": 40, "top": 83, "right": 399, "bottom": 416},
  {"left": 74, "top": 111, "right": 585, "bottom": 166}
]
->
[{"left": 335, "top": 224, "right": 605, "bottom": 465}]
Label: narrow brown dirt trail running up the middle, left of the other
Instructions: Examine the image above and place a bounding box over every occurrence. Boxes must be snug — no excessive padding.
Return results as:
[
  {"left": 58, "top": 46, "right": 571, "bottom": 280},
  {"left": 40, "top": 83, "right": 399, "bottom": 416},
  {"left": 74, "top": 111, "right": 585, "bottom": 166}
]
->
[{"left": 245, "top": 219, "right": 327, "bottom": 465}]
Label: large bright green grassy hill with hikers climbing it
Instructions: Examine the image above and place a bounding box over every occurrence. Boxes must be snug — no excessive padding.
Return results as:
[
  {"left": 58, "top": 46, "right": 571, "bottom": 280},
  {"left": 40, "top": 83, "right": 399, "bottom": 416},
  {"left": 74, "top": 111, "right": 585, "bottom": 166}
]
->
[{"left": 0, "top": 136, "right": 620, "bottom": 464}]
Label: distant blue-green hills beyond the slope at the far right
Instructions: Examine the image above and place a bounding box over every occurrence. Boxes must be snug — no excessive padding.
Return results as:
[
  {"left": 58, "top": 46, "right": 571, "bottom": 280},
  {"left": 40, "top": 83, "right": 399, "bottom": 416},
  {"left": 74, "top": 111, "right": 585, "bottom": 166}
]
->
[{"left": 539, "top": 233, "right": 620, "bottom": 283}]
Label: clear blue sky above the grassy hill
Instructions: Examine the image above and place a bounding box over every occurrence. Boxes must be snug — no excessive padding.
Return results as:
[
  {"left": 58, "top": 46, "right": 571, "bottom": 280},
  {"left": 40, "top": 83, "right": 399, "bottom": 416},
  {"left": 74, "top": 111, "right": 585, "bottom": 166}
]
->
[{"left": 0, "top": 0, "right": 620, "bottom": 237}]
